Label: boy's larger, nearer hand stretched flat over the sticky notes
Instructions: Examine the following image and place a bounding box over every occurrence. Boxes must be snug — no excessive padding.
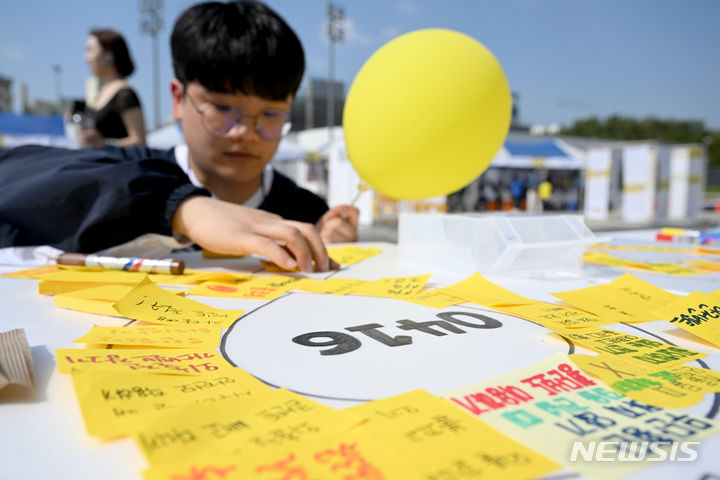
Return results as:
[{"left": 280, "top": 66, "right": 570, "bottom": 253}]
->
[{"left": 172, "top": 196, "right": 329, "bottom": 272}]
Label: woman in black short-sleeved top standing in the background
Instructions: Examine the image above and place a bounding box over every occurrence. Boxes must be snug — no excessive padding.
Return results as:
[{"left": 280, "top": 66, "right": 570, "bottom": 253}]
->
[{"left": 80, "top": 29, "right": 145, "bottom": 147}]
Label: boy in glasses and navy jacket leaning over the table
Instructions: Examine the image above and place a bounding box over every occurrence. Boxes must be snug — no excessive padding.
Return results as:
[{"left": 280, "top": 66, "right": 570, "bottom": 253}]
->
[{"left": 0, "top": 0, "right": 358, "bottom": 271}]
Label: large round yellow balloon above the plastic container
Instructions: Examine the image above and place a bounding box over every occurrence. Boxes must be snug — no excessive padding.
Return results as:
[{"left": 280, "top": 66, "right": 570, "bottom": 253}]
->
[{"left": 343, "top": 29, "right": 512, "bottom": 200}]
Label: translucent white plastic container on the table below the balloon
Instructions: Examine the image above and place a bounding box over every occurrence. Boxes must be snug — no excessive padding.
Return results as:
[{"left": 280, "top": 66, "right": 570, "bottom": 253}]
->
[{"left": 398, "top": 213, "right": 595, "bottom": 272}]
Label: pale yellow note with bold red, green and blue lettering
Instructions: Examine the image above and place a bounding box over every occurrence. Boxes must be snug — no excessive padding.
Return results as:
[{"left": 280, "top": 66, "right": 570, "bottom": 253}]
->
[{"left": 442, "top": 354, "right": 720, "bottom": 480}]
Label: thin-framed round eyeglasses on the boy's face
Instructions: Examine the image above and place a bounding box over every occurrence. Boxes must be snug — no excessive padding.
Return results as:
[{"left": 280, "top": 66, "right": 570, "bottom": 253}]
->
[{"left": 185, "top": 91, "right": 291, "bottom": 140}]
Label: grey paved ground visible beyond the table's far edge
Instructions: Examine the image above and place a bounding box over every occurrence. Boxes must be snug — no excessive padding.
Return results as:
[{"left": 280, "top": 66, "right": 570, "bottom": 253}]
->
[{"left": 358, "top": 211, "right": 720, "bottom": 243}]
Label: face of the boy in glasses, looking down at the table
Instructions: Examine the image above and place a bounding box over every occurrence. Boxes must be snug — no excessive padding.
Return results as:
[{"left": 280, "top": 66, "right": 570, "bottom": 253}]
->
[{"left": 171, "top": 79, "right": 292, "bottom": 187}]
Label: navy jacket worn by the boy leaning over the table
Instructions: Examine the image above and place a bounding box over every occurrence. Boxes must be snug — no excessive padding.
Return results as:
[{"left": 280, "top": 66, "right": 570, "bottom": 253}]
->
[{"left": 0, "top": 146, "right": 328, "bottom": 252}]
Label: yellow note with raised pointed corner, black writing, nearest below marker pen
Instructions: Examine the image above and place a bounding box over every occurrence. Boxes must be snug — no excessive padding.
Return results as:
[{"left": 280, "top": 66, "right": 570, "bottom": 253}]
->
[{"left": 114, "top": 279, "right": 243, "bottom": 328}]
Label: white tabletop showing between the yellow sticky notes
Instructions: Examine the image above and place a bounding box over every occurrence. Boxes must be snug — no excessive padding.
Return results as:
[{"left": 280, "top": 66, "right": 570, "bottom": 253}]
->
[{"left": 0, "top": 231, "right": 720, "bottom": 480}]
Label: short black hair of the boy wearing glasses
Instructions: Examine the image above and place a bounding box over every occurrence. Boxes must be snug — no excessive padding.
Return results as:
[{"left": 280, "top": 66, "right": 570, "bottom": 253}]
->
[{"left": 170, "top": 0, "right": 305, "bottom": 101}]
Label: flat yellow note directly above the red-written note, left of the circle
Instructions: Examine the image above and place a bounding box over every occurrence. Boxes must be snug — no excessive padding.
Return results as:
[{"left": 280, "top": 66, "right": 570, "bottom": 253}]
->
[{"left": 73, "top": 325, "right": 222, "bottom": 348}]
